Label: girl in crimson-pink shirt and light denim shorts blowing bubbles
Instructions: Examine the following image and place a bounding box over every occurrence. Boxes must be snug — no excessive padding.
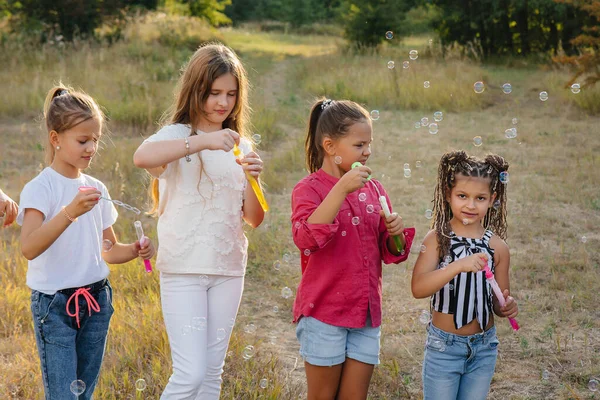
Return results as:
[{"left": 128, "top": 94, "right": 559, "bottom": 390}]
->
[{"left": 292, "top": 99, "right": 415, "bottom": 400}]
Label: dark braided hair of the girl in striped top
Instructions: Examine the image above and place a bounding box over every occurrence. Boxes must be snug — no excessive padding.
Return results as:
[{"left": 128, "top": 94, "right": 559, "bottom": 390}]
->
[{"left": 431, "top": 150, "right": 508, "bottom": 258}]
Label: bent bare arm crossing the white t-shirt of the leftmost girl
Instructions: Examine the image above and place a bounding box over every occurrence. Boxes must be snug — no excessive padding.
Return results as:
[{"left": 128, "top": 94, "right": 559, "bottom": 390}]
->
[{"left": 21, "top": 190, "right": 101, "bottom": 260}]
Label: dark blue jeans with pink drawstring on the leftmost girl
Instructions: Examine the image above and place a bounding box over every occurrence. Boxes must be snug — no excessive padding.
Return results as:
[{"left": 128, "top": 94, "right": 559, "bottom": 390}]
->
[{"left": 31, "top": 283, "right": 114, "bottom": 400}]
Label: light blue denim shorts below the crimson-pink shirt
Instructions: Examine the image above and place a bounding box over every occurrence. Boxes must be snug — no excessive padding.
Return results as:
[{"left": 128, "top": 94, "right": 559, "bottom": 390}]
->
[{"left": 296, "top": 317, "right": 381, "bottom": 367}]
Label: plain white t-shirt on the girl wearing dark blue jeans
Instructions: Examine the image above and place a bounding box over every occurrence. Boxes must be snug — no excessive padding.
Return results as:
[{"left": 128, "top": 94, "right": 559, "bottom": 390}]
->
[{"left": 17, "top": 167, "right": 118, "bottom": 294}]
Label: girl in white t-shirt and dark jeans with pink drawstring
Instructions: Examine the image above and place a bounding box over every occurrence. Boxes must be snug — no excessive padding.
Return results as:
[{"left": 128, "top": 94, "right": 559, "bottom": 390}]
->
[{"left": 17, "top": 86, "right": 154, "bottom": 400}]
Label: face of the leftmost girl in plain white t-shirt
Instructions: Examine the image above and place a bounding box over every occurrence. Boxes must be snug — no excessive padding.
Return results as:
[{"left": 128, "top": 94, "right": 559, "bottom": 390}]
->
[{"left": 50, "top": 118, "right": 102, "bottom": 170}]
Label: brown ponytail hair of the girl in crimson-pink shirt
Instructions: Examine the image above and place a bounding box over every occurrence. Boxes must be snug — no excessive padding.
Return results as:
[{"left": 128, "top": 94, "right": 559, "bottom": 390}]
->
[{"left": 304, "top": 98, "right": 371, "bottom": 173}]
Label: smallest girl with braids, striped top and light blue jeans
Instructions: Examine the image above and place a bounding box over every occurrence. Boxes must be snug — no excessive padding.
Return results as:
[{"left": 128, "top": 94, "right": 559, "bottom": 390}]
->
[{"left": 412, "top": 151, "right": 518, "bottom": 400}]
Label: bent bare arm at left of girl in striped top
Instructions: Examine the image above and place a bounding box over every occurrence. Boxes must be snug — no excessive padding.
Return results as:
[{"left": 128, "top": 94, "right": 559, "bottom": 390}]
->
[{"left": 411, "top": 230, "right": 486, "bottom": 299}]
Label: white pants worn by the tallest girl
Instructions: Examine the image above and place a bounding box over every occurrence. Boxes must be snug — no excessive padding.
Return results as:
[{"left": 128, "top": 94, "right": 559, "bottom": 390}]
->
[{"left": 160, "top": 273, "right": 244, "bottom": 400}]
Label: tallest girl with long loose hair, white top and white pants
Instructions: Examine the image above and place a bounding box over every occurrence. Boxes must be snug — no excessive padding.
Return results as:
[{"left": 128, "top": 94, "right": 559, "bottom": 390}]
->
[{"left": 134, "top": 44, "right": 264, "bottom": 400}]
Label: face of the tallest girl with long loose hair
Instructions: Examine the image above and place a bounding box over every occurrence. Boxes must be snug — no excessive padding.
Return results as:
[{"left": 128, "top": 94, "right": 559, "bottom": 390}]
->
[{"left": 200, "top": 73, "right": 238, "bottom": 126}]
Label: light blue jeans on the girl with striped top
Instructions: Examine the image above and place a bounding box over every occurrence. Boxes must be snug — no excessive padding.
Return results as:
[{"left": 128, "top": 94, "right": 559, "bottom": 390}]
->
[{"left": 423, "top": 324, "right": 498, "bottom": 400}]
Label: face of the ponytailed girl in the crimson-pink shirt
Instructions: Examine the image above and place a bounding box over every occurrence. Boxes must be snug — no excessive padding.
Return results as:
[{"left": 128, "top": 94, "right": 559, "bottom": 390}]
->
[{"left": 328, "top": 121, "right": 373, "bottom": 172}]
